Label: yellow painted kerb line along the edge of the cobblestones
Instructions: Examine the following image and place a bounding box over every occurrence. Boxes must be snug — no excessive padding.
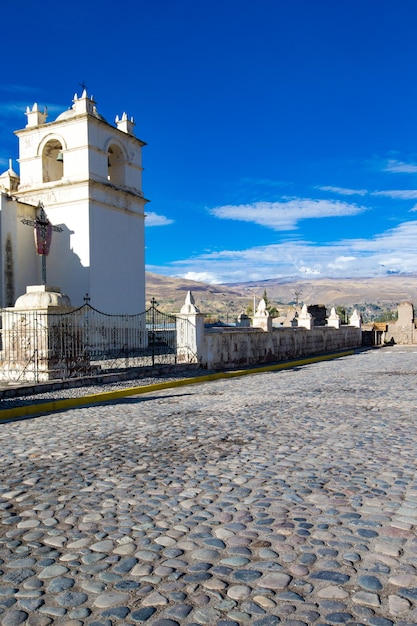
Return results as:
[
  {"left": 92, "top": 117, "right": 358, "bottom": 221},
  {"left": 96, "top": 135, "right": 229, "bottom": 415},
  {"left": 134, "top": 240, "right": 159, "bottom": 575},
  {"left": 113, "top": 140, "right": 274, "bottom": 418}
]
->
[{"left": 0, "top": 350, "right": 355, "bottom": 421}]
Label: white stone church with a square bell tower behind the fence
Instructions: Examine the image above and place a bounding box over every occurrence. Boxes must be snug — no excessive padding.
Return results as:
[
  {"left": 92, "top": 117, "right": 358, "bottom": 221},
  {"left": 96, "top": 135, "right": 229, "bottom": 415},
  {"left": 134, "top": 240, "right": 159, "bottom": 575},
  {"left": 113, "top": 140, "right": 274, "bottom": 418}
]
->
[{"left": 0, "top": 90, "right": 147, "bottom": 313}]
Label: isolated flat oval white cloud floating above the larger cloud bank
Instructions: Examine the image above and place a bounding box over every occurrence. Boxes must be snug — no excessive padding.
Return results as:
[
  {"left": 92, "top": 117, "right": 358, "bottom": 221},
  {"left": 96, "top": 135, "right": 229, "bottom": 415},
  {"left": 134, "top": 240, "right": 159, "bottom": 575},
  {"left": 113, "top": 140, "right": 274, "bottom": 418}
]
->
[{"left": 210, "top": 198, "right": 366, "bottom": 230}]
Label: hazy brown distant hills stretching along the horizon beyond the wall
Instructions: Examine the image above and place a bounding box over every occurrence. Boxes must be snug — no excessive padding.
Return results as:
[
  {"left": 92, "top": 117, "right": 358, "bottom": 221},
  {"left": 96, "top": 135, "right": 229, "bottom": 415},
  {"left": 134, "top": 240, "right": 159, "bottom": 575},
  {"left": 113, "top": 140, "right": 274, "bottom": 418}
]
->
[{"left": 146, "top": 272, "right": 417, "bottom": 319}]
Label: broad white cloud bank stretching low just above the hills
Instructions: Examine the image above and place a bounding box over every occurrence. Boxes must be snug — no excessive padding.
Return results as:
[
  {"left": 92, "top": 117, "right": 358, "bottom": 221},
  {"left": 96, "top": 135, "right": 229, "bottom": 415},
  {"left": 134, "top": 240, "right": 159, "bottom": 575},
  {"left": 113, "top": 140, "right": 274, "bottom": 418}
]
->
[{"left": 163, "top": 221, "right": 417, "bottom": 283}]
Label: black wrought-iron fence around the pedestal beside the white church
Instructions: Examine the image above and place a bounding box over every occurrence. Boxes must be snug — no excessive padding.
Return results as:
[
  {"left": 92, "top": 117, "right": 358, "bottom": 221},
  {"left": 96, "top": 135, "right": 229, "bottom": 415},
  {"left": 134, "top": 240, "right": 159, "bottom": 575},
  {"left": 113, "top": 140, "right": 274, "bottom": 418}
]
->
[{"left": 0, "top": 300, "right": 177, "bottom": 382}]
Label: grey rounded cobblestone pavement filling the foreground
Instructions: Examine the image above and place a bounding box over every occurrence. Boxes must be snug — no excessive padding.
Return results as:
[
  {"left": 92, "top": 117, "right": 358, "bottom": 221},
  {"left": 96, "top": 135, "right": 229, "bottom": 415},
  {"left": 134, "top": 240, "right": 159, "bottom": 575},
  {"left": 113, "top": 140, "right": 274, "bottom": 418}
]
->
[{"left": 0, "top": 346, "right": 417, "bottom": 626}]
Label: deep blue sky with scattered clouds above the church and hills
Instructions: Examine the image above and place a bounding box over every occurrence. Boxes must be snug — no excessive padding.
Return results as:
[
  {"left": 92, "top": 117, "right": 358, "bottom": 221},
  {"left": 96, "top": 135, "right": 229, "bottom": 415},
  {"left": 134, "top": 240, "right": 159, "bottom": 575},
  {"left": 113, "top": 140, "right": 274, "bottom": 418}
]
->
[{"left": 0, "top": 0, "right": 417, "bottom": 283}]
